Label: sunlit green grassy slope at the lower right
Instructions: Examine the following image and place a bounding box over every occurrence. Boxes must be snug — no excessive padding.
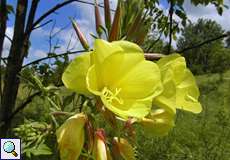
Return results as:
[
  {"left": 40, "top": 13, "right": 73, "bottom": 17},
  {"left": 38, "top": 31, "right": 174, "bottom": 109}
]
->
[{"left": 138, "top": 71, "right": 230, "bottom": 160}]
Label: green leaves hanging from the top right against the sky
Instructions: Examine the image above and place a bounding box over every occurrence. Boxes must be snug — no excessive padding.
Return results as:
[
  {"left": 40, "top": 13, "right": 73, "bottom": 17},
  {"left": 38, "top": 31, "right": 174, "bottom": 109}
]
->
[{"left": 145, "top": 0, "right": 228, "bottom": 40}]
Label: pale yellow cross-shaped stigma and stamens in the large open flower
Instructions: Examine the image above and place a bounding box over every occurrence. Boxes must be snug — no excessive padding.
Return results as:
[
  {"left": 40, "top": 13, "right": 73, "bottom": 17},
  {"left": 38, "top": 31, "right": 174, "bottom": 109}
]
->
[{"left": 102, "top": 87, "right": 123, "bottom": 104}]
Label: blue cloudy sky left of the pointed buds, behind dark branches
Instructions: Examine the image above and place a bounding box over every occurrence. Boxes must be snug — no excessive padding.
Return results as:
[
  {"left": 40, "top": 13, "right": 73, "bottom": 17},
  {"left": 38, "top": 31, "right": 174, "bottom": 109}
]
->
[{"left": 5, "top": 0, "right": 100, "bottom": 62}]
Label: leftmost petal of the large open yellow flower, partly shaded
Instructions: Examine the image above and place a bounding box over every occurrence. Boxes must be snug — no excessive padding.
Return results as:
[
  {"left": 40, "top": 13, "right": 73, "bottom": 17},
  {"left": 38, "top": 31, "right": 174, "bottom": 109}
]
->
[{"left": 62, "top": 52, "right": 91, "bottom": 95}]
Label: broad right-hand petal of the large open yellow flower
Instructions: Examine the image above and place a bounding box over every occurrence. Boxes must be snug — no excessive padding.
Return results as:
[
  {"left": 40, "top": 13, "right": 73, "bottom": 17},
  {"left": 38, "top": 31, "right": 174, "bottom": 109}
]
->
[{"left": 116, "top": 60, "right": 163, "bottom": 99}]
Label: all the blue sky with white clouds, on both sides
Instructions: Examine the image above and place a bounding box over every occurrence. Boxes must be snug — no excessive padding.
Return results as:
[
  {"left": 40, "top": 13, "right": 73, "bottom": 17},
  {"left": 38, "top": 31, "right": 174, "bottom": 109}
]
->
[{"left": 4, "top": 0, "right": 230, "bottom": 63}]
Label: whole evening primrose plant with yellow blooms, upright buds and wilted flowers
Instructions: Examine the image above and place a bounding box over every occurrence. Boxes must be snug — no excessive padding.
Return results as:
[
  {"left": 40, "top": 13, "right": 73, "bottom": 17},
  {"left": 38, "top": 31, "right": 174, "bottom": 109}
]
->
[{"left": 56, "top": 0, "right": 202, "bottom": 160}]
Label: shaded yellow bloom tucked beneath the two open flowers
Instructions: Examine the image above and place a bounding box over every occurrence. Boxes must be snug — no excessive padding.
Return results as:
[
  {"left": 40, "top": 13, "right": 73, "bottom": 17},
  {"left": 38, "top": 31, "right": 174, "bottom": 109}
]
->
[{"left": 140, "top": 109, "right": 175, "bottom": 137}]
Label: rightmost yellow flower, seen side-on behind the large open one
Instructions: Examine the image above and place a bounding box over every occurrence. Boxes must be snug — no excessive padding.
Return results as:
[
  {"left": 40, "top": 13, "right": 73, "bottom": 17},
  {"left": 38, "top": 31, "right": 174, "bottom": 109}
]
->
[{"left": 154, "top": 54, "right": 202, "bottom": 113}]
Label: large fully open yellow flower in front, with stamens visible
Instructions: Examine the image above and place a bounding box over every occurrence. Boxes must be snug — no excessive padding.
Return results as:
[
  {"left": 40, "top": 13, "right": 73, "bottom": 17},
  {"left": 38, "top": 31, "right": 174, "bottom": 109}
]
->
[{"left": 62, "top": 39, "right": 162, "bottom": 119}]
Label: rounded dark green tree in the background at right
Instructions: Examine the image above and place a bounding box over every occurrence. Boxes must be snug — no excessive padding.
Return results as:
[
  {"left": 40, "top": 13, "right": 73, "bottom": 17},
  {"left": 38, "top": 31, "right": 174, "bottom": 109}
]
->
[{"left": 177, "top": 19, "right": 228, "bottom": 74}]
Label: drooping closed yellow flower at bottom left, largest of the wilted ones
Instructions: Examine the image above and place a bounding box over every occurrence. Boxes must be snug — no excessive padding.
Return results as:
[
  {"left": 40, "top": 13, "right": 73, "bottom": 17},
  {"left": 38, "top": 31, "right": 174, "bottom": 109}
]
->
[{"left": 56, "top": 113, "right": 87, "bottom": 160}]
